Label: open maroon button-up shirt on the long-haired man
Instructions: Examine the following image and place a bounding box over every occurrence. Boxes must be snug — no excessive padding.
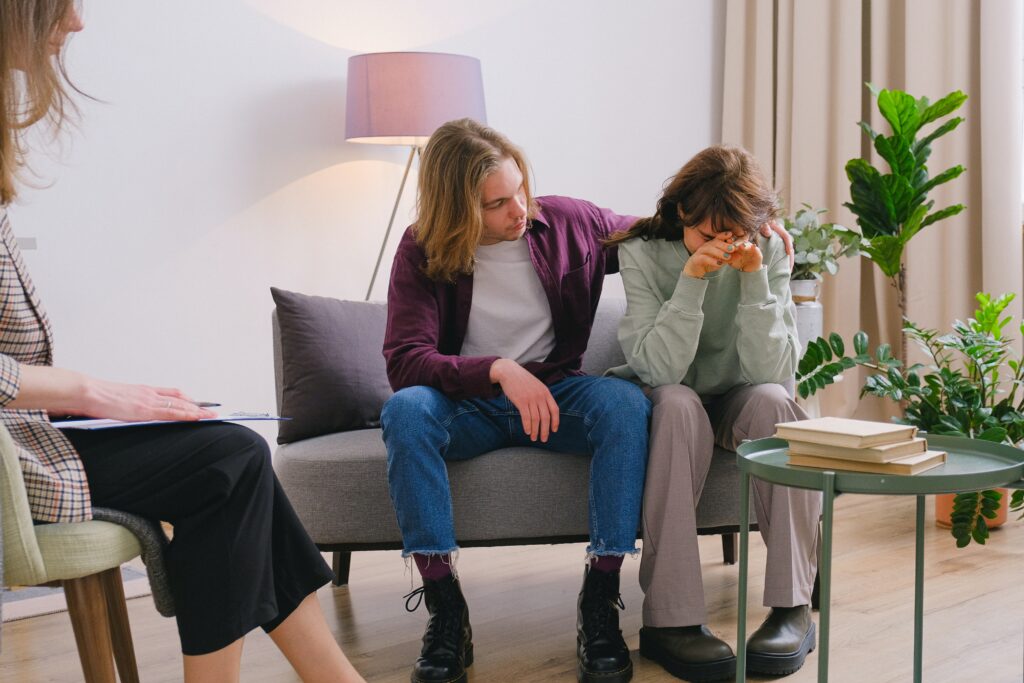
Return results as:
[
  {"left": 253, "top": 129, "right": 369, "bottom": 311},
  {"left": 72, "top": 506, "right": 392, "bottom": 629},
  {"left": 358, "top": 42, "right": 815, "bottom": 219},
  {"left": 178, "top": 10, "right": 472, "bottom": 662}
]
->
[{"left": 384, "top": 197, "right": 636, "bottom": 399}]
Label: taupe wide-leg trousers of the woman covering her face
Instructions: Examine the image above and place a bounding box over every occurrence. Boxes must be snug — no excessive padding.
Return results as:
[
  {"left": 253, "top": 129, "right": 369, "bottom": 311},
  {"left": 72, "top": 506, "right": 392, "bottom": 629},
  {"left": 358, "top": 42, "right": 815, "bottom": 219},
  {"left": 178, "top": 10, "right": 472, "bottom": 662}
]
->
[{"left": 640, "top": 384, "right": 821, "bottom": 627}]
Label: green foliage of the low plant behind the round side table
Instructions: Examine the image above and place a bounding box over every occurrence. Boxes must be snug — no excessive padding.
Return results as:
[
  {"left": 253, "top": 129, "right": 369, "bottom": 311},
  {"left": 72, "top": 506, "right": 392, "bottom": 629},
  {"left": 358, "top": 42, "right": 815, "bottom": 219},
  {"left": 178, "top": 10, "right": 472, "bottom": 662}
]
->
[{"left": 797, "top": 293, "right": 1024, "bottom": 547}]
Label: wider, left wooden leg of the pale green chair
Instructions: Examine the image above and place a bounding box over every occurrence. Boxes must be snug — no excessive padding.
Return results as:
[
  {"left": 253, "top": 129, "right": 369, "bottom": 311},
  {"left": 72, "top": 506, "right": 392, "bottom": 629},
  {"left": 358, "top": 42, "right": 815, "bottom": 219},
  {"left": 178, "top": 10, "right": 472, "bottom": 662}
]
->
[{"left": 63, "top": 574, "right": 117, "bottom": 683}]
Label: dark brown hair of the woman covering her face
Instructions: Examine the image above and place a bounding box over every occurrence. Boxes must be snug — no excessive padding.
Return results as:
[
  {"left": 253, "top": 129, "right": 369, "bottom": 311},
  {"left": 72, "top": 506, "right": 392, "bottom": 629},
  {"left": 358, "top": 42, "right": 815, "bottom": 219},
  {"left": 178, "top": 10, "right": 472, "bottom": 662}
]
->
[{"left": 605, "top": 145, "right": 779, "bottom": 246}]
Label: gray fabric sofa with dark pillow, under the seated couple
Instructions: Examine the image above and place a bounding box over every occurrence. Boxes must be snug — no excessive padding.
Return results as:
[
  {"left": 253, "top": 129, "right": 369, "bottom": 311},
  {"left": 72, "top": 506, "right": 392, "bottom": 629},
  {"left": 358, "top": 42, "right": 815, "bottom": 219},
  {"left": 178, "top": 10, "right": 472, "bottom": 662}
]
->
[{"left": 272, "top": 289, "right": 753, "bottom": 585}]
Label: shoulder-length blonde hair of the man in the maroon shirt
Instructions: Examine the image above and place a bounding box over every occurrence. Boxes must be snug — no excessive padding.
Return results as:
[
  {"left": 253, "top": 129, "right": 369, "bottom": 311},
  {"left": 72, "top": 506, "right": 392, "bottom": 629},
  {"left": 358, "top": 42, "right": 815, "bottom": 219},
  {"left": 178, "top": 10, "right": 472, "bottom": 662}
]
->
[{"left": 414, "top": 119, "right": 536, "bottom": 283}]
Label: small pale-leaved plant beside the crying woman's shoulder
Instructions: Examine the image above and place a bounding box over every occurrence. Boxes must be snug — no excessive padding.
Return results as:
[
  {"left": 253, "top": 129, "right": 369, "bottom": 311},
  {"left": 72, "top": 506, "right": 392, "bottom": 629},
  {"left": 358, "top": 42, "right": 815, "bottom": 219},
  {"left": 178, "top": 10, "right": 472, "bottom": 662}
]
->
[{"left": 783, "top": 204, "right": 860, "bottom": 280}]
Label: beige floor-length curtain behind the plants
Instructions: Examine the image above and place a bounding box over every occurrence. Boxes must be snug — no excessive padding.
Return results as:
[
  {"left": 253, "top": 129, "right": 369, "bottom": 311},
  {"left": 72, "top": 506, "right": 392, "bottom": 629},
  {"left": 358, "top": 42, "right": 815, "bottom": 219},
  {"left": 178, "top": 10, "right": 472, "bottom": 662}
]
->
[{"left": 722, "top": 0, "right": 1024, "bottom": 419}]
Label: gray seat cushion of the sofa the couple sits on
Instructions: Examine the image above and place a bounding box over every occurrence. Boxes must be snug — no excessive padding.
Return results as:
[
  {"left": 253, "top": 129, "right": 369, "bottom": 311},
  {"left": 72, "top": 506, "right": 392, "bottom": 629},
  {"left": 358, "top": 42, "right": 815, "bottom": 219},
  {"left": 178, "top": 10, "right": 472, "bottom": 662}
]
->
[{"left": 273, "top": 429, "right": 756, "bottom": 547}]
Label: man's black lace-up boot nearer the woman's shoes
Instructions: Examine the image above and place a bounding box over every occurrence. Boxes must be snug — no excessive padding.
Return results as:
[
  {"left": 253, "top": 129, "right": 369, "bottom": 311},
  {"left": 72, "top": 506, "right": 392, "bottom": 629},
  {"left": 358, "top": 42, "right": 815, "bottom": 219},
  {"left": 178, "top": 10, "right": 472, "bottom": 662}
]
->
[{"left": 577, "top": 565, "right": 633, "bottom": 683}]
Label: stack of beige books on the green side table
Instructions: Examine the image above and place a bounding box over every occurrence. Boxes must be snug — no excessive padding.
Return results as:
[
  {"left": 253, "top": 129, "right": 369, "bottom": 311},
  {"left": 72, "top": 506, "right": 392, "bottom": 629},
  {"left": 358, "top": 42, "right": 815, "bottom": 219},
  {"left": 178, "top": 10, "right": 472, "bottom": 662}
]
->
[{"left": 775, "top": 418, "right": 946, "bottom": 474}]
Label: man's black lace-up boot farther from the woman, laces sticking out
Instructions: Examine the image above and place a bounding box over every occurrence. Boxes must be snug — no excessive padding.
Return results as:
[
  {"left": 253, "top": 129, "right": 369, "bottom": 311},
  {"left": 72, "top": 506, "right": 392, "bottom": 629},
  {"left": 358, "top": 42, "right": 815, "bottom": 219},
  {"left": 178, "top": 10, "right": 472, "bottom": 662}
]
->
[{"left": 406, "top": 574, "right": 473, "bottom": 683}]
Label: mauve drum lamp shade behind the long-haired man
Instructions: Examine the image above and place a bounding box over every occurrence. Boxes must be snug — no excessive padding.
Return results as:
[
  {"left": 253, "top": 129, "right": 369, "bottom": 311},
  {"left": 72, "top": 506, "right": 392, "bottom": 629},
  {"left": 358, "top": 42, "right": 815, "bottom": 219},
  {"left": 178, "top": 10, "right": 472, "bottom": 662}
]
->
[{"left": 345, "top": 52, "right": 486, "bottom": 145}]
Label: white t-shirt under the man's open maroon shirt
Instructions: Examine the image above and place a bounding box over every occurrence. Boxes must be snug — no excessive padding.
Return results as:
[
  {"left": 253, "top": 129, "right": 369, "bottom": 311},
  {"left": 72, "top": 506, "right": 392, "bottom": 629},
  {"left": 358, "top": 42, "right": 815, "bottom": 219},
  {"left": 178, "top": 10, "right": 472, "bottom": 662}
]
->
[{"left": 460, "top": 238, "right": 555, "bottom": 365}]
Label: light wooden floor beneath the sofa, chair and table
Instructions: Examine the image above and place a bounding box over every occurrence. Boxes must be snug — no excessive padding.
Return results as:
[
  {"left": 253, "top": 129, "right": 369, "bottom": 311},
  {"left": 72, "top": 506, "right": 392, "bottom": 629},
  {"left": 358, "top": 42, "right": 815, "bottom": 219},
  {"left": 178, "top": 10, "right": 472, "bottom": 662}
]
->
[{"left": 0, "top": 495, "right": 1024, "bottom": 683}]
